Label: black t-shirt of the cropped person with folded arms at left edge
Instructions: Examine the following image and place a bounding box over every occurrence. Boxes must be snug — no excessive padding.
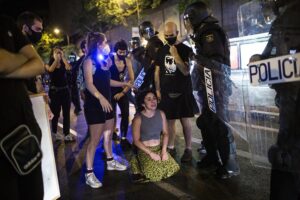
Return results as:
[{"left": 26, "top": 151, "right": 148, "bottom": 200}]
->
[{"left": 0, "top": 16, "right": 36, "bottom": 138}]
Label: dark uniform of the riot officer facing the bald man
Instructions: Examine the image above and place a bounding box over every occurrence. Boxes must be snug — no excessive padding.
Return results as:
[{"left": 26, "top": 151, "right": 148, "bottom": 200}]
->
[{"left": 193, "top": 20, "right": 230, "bottom": 173}]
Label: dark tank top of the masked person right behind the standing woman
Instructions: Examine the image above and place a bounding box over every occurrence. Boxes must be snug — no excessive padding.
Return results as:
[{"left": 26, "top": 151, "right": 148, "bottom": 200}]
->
[{"left": 109, "top": 56, "right": 127, "bottom": 95}]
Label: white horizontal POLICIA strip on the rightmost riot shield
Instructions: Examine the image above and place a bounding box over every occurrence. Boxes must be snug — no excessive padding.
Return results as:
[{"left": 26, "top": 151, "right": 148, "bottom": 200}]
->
[{"left": 248, "top": 53, "right": 300, "bottom": 86}]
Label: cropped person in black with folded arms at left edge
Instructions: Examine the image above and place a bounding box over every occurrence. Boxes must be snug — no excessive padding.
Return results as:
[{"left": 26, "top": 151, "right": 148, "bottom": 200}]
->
[{"left": 0, "top": 16, "right": 44, "bottom": 200}]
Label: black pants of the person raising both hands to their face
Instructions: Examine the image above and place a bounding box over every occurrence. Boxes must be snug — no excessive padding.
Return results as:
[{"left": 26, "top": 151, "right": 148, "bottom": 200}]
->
[{"left": 49, "top": 89, "right": 71, "bottom": 135}]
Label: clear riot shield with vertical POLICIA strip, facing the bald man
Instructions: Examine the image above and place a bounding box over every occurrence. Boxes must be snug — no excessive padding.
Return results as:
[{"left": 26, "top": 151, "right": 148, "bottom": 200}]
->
[{"left": 191, "top": 56, "right": 240, "bottom": 175}]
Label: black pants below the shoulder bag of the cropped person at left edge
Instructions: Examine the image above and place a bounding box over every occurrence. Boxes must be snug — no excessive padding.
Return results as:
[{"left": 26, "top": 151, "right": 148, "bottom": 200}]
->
[{"left": 0, "top": 156, "right": 44, "bottom": 200}]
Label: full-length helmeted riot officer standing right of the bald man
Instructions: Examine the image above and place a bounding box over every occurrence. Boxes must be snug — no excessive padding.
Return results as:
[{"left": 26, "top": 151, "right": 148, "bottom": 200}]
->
[{"left": 184, "top": 2, "right": 233, "bottom": 179}]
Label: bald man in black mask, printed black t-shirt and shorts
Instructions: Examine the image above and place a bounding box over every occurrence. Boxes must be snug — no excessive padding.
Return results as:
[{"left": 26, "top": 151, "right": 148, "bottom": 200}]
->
[{"left": 154, "top": 22, "right": 196, "bottom": 162}]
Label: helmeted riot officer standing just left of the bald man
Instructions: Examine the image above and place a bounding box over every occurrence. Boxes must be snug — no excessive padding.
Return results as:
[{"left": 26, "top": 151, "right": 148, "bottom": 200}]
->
[{"left": 139, "top": 21, "right": 163, "bottom": 90}]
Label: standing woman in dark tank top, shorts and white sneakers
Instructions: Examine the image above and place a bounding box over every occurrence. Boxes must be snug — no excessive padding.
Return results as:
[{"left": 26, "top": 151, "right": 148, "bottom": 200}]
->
[{"left": 83, "top": 33, "right": 130, "bottom": 188}]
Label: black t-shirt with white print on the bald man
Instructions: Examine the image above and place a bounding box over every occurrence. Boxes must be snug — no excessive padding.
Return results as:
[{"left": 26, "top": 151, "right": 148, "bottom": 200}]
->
[{"left": 154, "top": 43, "right": 192, "bottom": 93}]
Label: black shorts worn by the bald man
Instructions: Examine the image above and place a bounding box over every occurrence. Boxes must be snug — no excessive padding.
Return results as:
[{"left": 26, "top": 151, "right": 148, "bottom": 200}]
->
[{"left": 159, "top": 93, "right": 197, "bottom": 120}]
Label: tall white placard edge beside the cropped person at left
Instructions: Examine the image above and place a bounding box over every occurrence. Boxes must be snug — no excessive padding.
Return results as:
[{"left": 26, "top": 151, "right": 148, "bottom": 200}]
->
[{"left": 30, "top": 95, "right": 60, "bottom": 200}]
